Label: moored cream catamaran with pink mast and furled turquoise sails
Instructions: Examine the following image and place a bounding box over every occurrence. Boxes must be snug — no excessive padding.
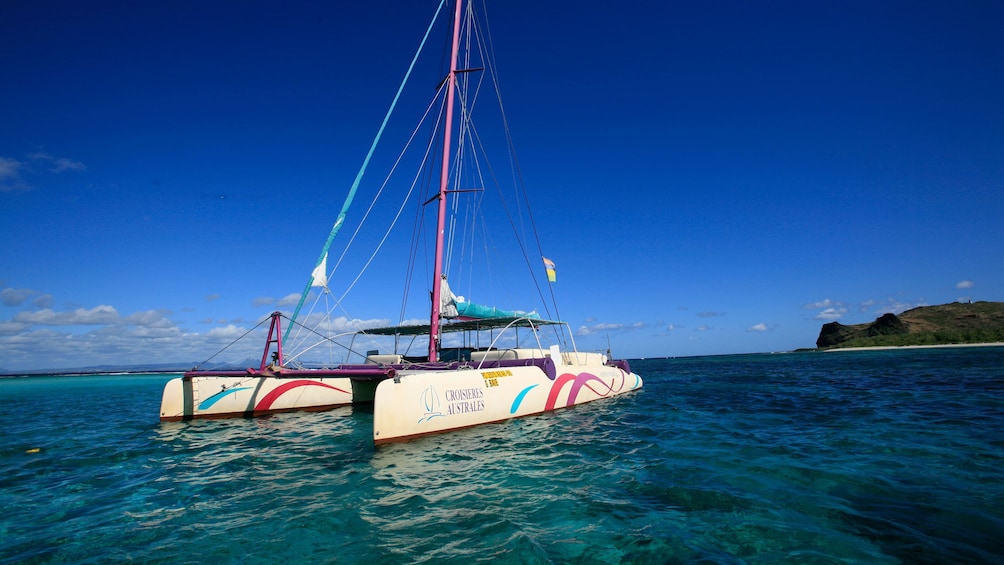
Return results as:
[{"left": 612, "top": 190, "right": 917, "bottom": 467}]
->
[{"left": 161, "top": 0, "right": 643, "bottom": 445}]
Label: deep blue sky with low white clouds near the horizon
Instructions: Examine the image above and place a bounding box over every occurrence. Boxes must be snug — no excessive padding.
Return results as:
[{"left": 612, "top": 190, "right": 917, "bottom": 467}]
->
[{"left": 0, "top": 0, "right": 1004, "bottom": 370}]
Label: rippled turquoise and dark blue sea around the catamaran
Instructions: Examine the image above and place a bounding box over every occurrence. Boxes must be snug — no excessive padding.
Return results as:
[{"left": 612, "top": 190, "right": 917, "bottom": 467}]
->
[{"left": 0, "top": 347, "right": 1004, "bottom": 565}]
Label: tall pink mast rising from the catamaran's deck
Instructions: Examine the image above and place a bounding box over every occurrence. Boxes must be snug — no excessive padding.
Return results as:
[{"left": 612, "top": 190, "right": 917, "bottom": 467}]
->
[{"left": 429, "top": 0, "right": 463, "bottom": 361}]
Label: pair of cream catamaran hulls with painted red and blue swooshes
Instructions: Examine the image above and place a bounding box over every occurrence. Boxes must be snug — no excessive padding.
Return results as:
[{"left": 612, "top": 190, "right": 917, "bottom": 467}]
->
[{"left": 161, "top": 358, "right": 642, "bottom": 445}]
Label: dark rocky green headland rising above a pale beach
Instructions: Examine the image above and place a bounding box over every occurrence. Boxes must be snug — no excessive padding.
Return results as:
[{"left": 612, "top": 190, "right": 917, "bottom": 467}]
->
[{"left": 816, "top": 302, "right": 1004, "bottom": 349}]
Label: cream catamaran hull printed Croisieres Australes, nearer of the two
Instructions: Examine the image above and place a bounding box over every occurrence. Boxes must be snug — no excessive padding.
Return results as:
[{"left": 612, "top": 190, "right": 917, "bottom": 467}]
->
[{"left": 373, "top": 357, "right": 642, "bottom": 445}]
